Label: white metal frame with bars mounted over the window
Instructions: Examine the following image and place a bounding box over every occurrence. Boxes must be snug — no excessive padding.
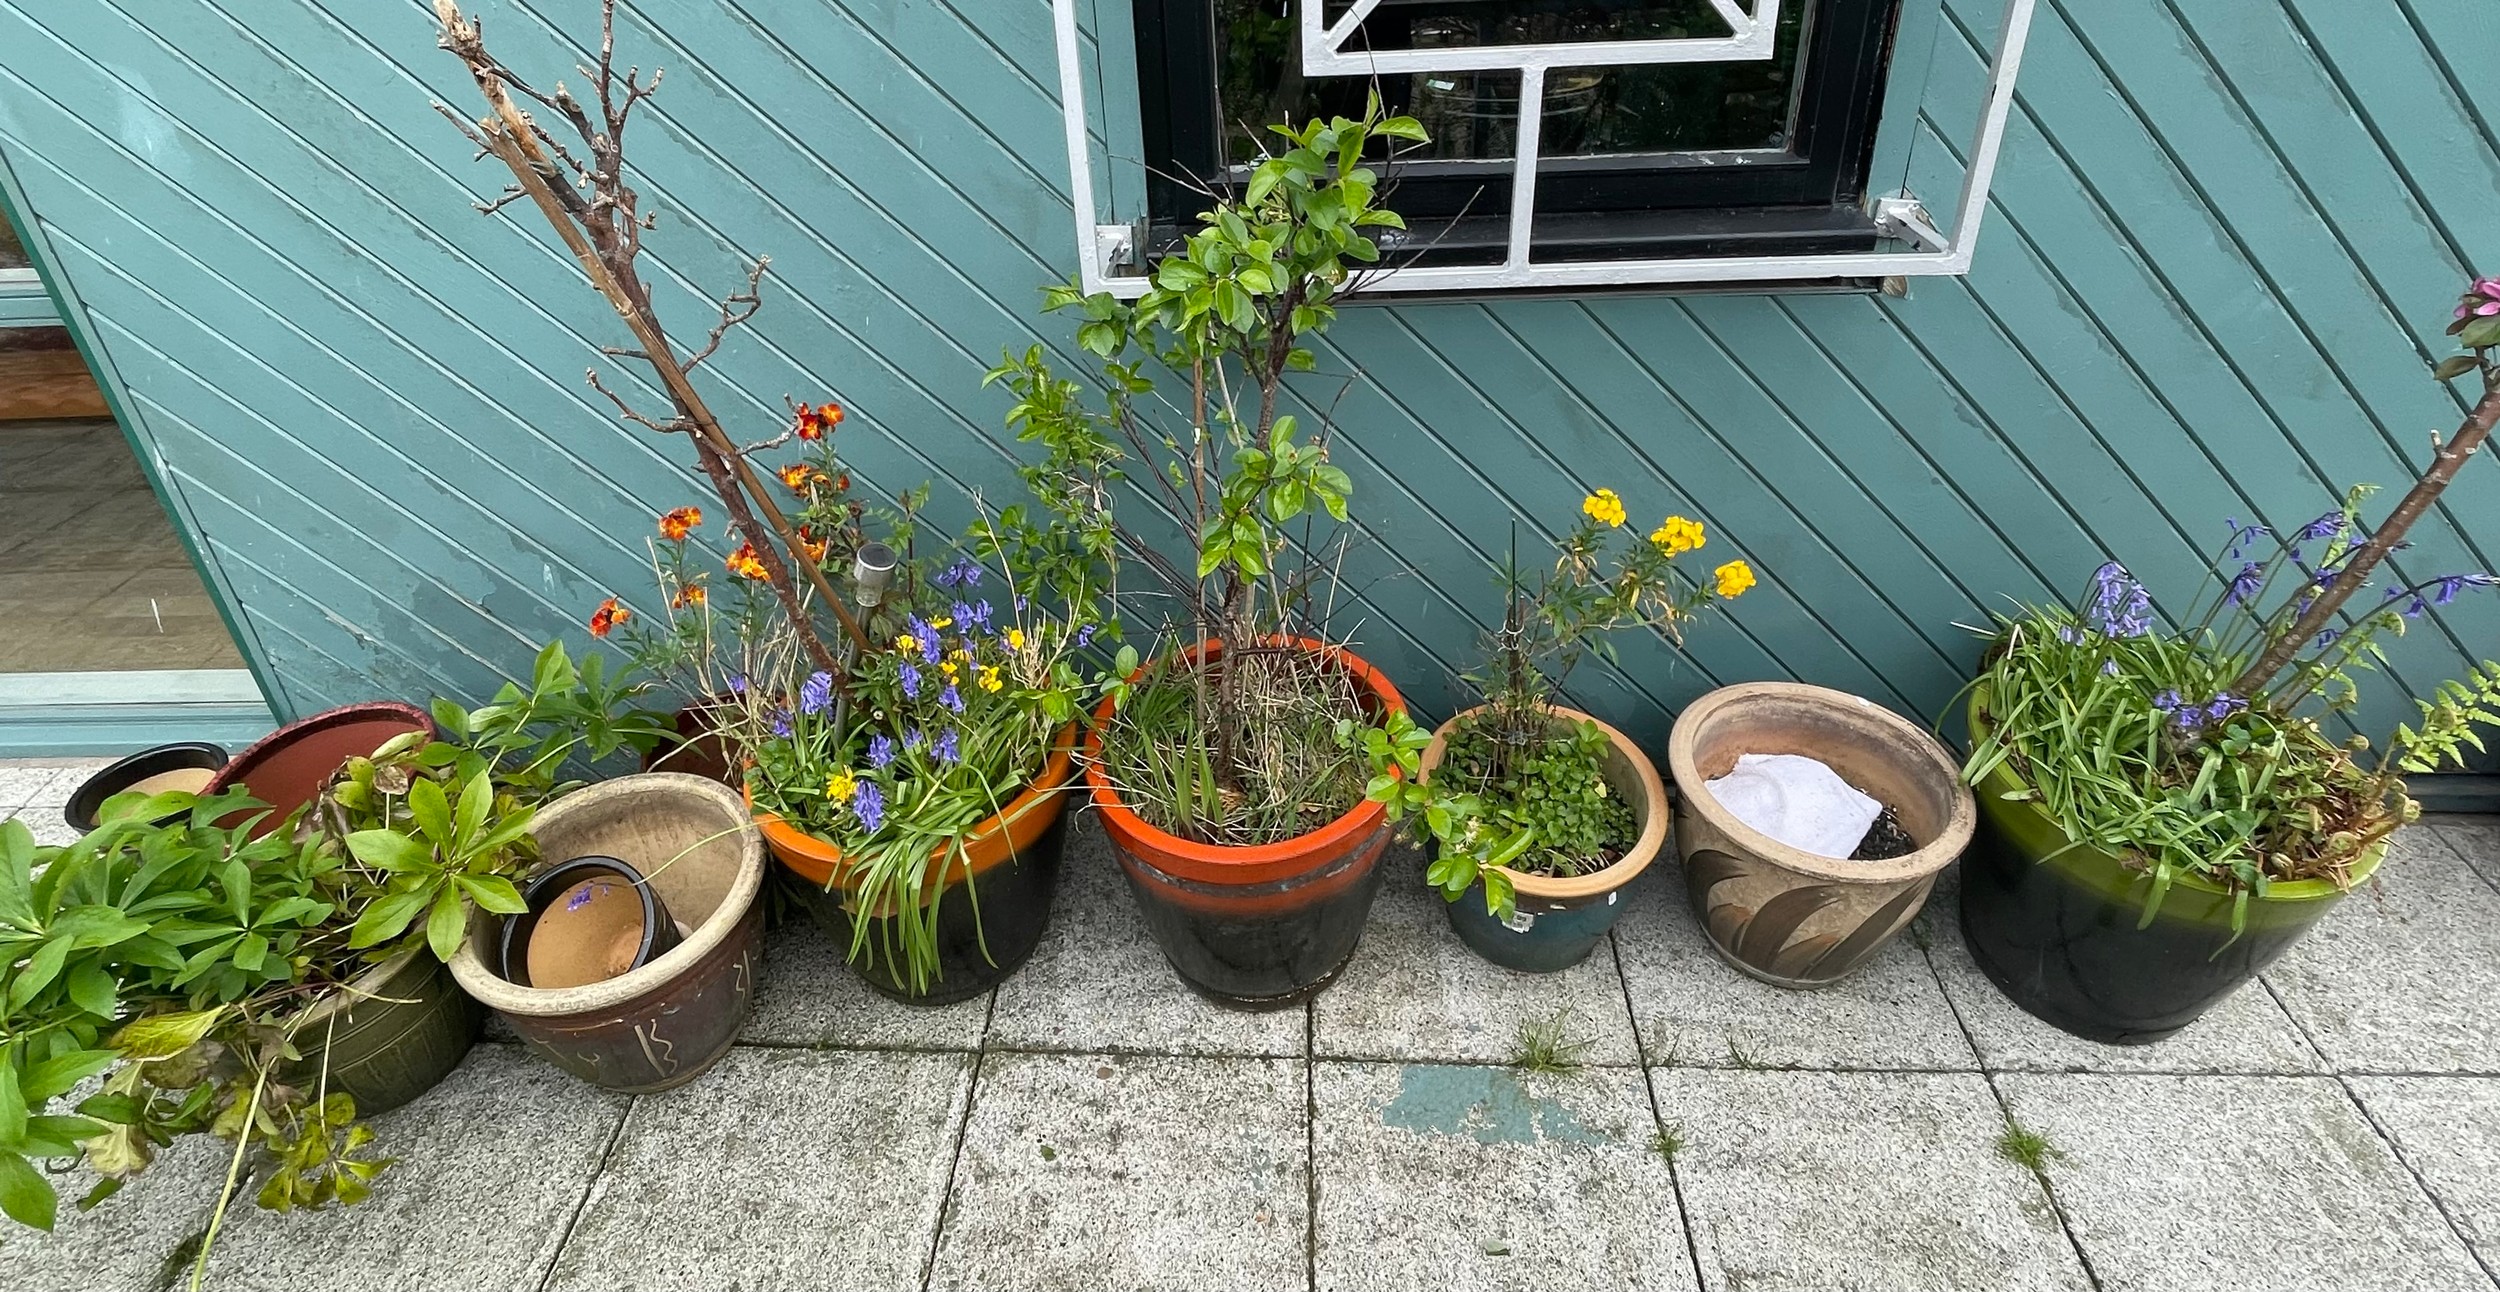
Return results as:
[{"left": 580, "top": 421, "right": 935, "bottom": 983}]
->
[{"left": 1050, "top": 0, "right": 2038, "bottom": 300}]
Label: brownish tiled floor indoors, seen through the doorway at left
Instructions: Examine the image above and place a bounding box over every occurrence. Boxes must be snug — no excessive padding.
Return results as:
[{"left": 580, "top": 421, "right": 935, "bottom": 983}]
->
[{"left": 0, "top": 420, "right": 243, "bottom": 672}]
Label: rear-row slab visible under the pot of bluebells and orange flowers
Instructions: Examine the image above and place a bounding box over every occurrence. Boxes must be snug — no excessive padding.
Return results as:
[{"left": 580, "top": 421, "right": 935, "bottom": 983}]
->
[{"left": 738, "top": 920, "right": 990, "bottom": 1050}]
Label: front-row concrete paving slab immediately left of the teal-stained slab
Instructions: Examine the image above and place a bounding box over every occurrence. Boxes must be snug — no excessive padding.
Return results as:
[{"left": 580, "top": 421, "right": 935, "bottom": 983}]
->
[{"left": 930, "top": 1052, "right": 1310, "bottom": 1292}]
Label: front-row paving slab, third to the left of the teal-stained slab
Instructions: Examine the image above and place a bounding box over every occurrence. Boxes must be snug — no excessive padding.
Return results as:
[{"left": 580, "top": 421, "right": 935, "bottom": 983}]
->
[{"left": 193, "top": 1045, "right": 625, "bottom": 1292}]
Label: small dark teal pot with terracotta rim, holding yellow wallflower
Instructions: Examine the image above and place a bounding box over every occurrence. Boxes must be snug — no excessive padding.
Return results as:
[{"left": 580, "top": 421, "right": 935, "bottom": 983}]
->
[{"left": 1423, "top": 707, "right": 1668, "bottom": 975}]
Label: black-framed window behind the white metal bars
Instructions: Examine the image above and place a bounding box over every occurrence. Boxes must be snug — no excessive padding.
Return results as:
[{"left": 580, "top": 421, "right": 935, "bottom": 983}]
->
[{"left": 1135, "top": 0, "right": 1900, "bottom": 267}]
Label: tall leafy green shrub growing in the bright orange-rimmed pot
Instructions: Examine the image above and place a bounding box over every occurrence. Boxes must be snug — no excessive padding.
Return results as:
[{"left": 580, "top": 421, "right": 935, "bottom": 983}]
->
[{"left": 990, "top": 95, "right": 1425, "bottom": 845}]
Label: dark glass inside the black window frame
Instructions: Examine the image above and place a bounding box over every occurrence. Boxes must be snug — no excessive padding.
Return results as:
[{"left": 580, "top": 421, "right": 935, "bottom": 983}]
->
[{"left": 1215, "top": 0, "right": 1815, "bottom": 165}]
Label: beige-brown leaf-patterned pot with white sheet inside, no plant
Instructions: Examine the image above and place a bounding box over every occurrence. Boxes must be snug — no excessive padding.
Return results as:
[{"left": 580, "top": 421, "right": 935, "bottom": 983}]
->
[{"left": 1668, "top": 682, "right": 1978, "bottom": 987}]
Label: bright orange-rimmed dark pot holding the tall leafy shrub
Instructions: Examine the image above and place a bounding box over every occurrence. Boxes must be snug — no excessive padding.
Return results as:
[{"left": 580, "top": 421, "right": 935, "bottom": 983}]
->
[{"left": 1085, "top": 637, "right": 1405, "bottom": 1010}]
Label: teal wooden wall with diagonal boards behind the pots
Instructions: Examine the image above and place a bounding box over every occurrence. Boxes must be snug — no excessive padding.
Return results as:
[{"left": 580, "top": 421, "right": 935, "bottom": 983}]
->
[{"left": 0, "top": 0, "right": 2500, "bottom": 759}]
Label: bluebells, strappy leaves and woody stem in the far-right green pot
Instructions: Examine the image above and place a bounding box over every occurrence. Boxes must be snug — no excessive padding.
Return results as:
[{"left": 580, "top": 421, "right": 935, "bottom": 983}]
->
[{"left": 1965, "top": 277, "right": 2500, "bottom": 927}]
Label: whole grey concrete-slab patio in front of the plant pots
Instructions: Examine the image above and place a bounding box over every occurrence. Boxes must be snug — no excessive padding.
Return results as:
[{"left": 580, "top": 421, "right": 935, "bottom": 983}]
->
[{"left": 0, "top": 749, "right": 2500, "bottom": 1292}]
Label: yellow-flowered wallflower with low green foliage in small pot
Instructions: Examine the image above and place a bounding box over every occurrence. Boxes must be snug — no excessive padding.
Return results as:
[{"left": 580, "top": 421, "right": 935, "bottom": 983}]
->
[{"left": 1350, "top": 490, "right": 1755, "bottom": 917}]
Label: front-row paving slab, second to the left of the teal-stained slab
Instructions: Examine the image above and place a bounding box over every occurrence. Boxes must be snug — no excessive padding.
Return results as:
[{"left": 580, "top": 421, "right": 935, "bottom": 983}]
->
[{"left": 545, "top": 1050, "right": 973, "bottom": 1292}]
